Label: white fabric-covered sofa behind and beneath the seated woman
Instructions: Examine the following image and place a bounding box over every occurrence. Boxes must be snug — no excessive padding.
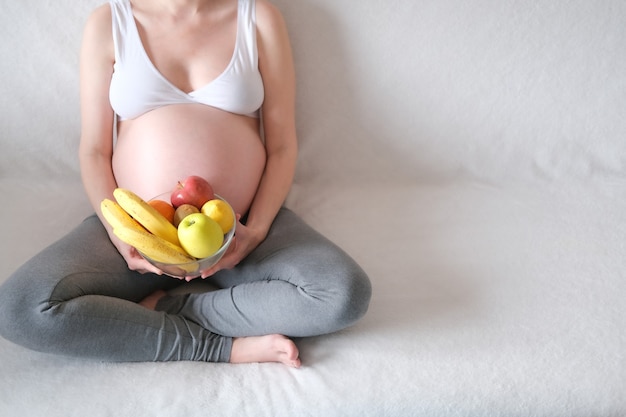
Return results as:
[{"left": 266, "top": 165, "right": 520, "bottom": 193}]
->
[{"left": 0, "top": 0, "right": 626, "bottom": 417}]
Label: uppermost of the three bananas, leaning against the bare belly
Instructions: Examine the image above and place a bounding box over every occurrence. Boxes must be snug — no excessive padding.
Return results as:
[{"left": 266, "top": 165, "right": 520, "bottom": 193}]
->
[{"left": 113, "top": 188, "right": 180, "bottom": 246}]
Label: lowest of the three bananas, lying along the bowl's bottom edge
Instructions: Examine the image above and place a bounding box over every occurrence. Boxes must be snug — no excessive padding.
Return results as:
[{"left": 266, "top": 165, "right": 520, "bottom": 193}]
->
[{"left": 113, "top": 226, "right": 195, "bottom": 264}]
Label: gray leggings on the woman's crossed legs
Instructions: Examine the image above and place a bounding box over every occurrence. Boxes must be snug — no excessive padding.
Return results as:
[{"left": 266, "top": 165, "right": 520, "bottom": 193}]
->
[{"left": 0, "top": 208, "right": 371, "bottom": 362}]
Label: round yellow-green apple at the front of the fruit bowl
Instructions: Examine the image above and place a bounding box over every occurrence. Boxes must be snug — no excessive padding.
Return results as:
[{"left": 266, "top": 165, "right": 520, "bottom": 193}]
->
[{"left": 178, "top": 213, "right": 224, "bottom": 258}]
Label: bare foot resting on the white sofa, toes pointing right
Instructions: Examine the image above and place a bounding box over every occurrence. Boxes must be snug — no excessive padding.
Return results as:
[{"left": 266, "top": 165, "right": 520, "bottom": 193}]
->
[{"left": 230, "top": 334, "right": 301, "bottom": 368}]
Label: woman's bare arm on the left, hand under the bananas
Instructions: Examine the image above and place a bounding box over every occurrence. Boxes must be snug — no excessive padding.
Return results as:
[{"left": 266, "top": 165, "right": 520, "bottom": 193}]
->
[{"left": 79, "top": 4, "right": 161, "bottom": 274}]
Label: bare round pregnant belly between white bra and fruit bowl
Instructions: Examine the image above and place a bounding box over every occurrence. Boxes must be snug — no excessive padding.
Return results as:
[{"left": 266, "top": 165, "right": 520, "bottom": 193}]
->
[{"left": 113, "top": 104, "right": 266, "bottom": 214}]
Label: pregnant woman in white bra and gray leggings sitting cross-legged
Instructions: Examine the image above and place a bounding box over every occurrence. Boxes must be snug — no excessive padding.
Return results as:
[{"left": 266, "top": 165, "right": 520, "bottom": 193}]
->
[{"left": 0, "top": 0, "right": 371, "bottom": 367}]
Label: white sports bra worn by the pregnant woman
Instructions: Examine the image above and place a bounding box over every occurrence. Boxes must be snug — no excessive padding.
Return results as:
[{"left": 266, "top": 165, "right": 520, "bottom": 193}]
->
[{"left": 109, "top": 0, "right": 265, "bottom": 120}]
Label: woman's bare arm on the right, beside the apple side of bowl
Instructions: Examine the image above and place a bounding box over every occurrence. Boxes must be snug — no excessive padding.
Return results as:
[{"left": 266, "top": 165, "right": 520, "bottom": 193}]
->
[{"left": 202, "top": 0, "right": 298, "bottom": 277}]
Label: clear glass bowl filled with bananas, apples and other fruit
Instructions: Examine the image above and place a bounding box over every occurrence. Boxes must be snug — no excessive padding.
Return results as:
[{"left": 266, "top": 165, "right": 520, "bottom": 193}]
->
[{"left": 101, "top": 176, "right": 237, "bottom": 278}]
